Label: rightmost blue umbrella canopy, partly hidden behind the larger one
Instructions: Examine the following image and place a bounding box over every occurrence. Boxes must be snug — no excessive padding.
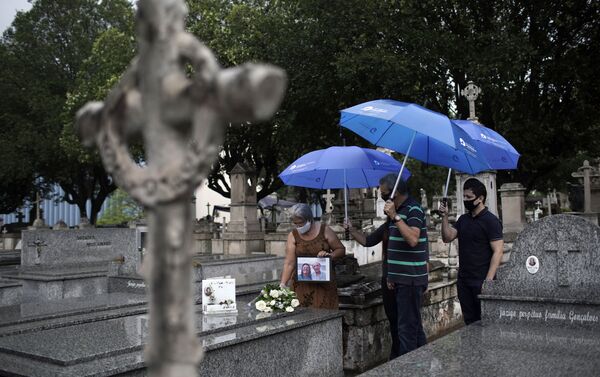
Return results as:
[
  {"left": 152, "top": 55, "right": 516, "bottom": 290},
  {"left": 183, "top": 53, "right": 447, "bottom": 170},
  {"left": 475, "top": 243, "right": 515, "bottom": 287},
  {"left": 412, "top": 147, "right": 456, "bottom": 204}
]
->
[{"left": 452, "top": 120, "right": 521, "bottom": 170}]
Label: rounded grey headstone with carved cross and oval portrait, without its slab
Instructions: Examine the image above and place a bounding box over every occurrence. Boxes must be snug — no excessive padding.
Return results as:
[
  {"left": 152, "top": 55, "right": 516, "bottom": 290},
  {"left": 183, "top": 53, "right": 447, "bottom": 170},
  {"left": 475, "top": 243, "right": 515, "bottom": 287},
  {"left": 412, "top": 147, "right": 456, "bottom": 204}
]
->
[{"left": 482, "top": 215, "right": 600, "bottom": 330}]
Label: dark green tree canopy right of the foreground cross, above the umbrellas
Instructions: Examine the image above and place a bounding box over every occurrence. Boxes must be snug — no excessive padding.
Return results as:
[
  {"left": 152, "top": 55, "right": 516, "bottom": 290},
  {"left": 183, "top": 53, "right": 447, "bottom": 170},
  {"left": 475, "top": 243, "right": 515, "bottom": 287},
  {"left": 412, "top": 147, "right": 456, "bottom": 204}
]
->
[{"left": 188, "top": 0, "right": 600, "bottom": 198}]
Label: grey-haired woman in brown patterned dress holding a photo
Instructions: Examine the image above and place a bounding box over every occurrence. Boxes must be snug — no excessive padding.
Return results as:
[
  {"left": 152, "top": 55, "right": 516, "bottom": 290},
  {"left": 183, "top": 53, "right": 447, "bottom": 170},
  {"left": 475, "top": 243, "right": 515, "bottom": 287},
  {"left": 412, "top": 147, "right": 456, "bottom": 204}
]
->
[{"left": 281, "top": 203, "right": 346, "bottom": 309}]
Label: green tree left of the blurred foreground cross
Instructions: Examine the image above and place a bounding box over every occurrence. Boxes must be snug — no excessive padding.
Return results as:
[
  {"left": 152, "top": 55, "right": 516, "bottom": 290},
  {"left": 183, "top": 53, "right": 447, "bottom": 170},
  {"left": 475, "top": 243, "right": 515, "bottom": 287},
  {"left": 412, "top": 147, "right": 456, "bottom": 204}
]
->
[{"left": 0, "top": 0, "right": 133, "bottom": 222}]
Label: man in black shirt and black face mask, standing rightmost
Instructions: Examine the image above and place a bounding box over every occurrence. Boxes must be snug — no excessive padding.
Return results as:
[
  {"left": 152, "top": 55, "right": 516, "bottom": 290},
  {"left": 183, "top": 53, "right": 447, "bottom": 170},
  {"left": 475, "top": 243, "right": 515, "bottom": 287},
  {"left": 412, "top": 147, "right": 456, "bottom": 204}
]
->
[{"left": 440, "top": 178, "right": 504, "bottom": 325}]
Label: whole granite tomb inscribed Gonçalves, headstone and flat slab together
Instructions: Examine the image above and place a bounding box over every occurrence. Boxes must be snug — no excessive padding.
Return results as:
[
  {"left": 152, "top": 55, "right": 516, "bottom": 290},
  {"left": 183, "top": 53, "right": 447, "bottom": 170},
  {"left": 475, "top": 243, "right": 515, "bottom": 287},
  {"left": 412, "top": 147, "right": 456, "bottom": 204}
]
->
[{"left": 363, "top": 215, "right": 600, "bottom": 377}]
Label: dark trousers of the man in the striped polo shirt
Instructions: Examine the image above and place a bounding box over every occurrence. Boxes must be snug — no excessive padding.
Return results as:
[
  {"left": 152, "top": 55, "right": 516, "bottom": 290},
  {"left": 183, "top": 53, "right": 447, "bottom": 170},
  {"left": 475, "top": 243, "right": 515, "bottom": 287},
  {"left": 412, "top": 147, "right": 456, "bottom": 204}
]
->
[{"left": 391, "top": 284, "right": 427, "bottom": 358}]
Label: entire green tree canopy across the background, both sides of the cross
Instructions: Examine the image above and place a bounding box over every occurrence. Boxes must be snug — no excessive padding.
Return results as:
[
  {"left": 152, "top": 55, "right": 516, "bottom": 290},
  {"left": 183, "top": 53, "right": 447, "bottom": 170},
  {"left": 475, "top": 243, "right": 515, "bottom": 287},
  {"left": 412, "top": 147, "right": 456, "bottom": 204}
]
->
[{"left": 0, "top": 0, "right": 600, "bottom": 214}]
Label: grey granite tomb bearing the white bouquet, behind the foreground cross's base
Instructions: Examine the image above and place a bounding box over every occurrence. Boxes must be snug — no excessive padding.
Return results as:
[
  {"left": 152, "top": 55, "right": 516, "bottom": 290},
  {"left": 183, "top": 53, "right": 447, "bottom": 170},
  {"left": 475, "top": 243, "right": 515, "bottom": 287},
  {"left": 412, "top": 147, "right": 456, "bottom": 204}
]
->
[{"left": 0, "top": 300, "right": 343, "bottom": 377}]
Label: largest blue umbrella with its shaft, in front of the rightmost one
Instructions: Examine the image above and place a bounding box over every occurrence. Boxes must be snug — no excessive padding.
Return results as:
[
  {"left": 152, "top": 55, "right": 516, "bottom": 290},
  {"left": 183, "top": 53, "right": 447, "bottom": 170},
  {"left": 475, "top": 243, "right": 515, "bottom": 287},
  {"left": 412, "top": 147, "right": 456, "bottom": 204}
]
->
[{"left": 340, "top": 100, "right": 490, "bottom": 194}]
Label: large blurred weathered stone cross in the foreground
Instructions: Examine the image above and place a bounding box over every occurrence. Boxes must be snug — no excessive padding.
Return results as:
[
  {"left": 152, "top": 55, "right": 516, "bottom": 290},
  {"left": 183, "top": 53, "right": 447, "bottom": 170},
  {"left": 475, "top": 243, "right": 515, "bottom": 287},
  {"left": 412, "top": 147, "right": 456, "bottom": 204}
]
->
[{"left": 76, "top": 0, "right": 286, "bottom": 377}]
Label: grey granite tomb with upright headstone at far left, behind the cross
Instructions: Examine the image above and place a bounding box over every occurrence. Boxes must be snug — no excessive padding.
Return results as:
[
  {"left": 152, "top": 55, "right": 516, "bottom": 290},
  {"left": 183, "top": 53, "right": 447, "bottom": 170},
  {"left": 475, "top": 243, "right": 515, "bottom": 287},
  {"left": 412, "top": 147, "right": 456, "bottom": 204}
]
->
[{"left": 10, "top": 228, "right": 141, "bottom": 305}]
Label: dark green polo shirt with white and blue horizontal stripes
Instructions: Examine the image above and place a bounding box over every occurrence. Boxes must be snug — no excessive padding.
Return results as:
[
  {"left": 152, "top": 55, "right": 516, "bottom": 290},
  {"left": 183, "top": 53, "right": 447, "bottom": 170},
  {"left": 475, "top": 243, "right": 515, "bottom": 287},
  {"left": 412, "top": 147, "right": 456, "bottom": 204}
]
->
[{"left": 387, "top": 196, "right": 429, "bottom": 286}]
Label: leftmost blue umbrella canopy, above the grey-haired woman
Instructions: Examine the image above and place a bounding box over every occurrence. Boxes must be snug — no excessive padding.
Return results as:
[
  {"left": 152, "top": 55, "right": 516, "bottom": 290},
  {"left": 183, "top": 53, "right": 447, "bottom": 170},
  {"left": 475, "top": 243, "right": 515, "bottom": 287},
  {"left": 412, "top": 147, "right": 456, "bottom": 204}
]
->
[{"left": 279, "top": 146, "right": 410, "bottom": 189}]
